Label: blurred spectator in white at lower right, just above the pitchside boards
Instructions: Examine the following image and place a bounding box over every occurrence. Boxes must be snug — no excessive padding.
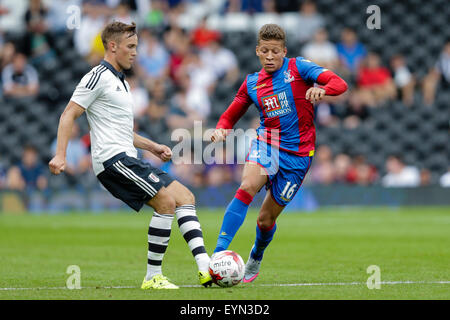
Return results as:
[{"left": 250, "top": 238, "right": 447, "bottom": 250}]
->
[{"left": 381, "top": 155, "right": 420, "bottom": 187}]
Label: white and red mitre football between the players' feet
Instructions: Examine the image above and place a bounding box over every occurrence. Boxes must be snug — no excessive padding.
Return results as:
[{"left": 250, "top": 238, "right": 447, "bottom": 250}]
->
[{"left": 209, "top": 250, "right": 245, "bottom": 288}]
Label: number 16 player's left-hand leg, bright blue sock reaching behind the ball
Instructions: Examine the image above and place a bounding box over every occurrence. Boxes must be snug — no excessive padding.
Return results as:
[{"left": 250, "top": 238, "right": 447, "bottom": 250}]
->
[{"left": 214, "top": 162, "right": 268, "bottom": 253}]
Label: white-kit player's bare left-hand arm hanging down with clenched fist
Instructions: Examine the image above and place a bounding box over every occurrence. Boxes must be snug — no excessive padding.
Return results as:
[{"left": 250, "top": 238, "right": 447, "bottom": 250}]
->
[{"left": 48, "top": 101, "right": 85, "bottom": 174}]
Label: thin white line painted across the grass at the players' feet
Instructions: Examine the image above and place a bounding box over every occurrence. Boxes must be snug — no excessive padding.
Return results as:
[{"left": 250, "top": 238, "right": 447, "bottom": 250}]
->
[{"left": 0, "top": 281, "right": 450, "bottom": 291}]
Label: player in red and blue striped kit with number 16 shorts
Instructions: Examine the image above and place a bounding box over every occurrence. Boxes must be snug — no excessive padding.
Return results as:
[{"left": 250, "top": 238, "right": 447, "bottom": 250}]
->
[{"left": 211, "top": 24, "right": 347, "bottom": 282}]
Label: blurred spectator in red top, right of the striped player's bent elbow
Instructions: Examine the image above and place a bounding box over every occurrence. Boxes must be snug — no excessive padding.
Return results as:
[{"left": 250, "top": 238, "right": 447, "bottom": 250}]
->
[{"left": 357, "top": 52, "right": 396, "bottom": 107}]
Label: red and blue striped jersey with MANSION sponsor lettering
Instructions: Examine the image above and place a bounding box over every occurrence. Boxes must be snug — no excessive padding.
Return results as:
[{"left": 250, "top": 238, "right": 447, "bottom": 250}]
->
[{"left": 217, "top": 57, "right": 330, "bottom": 156}]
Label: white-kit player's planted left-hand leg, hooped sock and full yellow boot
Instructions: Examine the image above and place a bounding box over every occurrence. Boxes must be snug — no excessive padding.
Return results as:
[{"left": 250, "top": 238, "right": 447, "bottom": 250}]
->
[{"left": 141, "top": 187, "right": 178, "bottom": 289}]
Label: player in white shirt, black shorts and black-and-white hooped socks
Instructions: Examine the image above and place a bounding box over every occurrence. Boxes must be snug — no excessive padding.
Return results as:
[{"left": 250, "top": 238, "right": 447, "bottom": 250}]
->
[{"left": 49, "top": 22, "right": 212, "bottom": 289}]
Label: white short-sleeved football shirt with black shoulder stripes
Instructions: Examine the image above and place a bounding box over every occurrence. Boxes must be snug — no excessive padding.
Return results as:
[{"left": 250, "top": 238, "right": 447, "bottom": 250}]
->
[{"left": 70, "top": 60, "right": 137, "bottom": 175}]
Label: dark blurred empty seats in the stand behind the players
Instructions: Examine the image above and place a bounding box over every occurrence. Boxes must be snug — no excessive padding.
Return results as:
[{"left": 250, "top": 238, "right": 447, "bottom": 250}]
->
[{"left": 0, "top": 0, "right": 450, "bottom": 198}]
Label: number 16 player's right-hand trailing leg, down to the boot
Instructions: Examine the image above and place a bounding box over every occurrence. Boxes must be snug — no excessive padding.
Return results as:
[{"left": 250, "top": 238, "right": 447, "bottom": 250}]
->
[{"left": 243, "top": 190, "right": 284, "bottom": 283}]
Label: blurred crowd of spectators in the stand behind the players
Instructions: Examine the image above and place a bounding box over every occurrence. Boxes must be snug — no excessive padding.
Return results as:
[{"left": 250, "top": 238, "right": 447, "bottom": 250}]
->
[{"left": 0, "top": 0, "right": 450, "bottom": 196}]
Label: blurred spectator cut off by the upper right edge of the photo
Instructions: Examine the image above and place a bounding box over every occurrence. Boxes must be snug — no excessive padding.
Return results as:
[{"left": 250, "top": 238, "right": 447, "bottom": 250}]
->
[{"left": 422, "top": 40, "right": 450, "bottom": 106}]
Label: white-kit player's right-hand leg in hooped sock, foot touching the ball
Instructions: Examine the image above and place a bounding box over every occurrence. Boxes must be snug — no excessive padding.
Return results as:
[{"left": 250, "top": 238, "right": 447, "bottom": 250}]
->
[{"left": 166, "top": 181, "right": 212, "bottom": 287}]
